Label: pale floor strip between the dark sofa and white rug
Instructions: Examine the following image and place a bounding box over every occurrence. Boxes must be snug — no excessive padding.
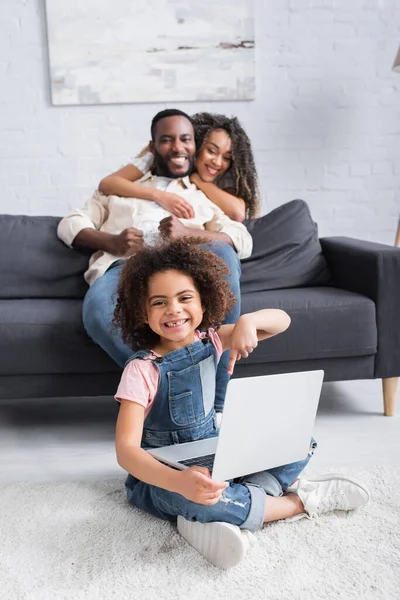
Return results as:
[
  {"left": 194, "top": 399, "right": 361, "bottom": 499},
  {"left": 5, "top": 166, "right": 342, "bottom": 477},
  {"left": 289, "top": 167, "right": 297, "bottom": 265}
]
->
[{"left": 0, "top": 380, "right": 400, "bottom": 483}]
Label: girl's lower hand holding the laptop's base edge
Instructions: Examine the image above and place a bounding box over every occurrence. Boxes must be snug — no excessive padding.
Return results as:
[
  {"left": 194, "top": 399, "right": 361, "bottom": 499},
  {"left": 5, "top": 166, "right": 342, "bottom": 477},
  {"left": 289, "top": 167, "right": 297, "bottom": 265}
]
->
[{"left": 177, "top": 467, "right": 229, "bottom": 505}]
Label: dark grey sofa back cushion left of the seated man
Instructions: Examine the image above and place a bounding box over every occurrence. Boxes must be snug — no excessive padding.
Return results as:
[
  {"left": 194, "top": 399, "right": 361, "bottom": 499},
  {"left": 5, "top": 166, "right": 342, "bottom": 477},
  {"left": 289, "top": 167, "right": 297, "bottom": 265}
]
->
[{"left": 0, "top": 215, "right": 90, "bottom": 298}]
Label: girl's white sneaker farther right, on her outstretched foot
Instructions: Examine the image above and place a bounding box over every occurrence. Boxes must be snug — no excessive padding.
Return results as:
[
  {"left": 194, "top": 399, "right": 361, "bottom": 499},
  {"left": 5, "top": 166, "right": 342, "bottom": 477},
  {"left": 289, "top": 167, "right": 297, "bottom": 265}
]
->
[{"left": 287, "top": 473, "right": 370, "bottom": 520}]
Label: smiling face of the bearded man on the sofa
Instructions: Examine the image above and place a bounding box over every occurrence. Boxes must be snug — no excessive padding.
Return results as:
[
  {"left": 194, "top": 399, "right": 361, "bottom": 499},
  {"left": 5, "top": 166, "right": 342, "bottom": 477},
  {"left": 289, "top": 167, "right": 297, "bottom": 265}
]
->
[{"left": 150, "top": 115, "right": 196, "bottom": 179}]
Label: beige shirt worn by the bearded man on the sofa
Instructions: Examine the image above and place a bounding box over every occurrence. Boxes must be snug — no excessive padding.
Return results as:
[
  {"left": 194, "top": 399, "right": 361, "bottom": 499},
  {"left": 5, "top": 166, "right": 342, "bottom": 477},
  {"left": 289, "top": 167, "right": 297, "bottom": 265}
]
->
[{"left": 57, "top": 172, "right": 253, "bottom": 285}]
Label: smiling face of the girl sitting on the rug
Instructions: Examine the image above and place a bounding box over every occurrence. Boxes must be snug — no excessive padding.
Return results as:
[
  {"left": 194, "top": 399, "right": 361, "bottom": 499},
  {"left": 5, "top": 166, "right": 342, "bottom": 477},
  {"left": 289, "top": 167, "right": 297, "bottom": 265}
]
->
[{"left": 146, "top": 269, "right": 204, "bottom": 353}]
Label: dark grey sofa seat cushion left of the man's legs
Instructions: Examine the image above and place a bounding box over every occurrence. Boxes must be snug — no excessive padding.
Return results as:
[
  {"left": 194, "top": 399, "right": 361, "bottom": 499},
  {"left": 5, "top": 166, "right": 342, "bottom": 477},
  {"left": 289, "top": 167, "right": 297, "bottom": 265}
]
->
[{"left": 0, "top": 299, "right": 120, "bottom": 375}]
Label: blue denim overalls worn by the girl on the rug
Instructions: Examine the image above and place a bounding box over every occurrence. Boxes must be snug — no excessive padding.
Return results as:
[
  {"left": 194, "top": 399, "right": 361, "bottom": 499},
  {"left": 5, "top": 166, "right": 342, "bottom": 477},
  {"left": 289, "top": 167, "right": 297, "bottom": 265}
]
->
[{"left": 125, "top": 337, "right": 318, "bottom": 531}]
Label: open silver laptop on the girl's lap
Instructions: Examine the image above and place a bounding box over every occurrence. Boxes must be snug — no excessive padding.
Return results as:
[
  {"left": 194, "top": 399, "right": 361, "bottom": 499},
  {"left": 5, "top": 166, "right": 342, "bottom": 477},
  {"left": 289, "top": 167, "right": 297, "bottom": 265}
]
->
[{"left": 147, "top": 371, "right": 324, "bottom": 481}]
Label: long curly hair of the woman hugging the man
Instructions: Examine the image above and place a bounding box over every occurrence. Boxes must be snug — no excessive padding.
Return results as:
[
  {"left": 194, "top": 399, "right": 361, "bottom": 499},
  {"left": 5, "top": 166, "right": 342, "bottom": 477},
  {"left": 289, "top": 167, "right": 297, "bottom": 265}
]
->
[{"left": 192, "top": 112, "right": 259, "bottom": 219}]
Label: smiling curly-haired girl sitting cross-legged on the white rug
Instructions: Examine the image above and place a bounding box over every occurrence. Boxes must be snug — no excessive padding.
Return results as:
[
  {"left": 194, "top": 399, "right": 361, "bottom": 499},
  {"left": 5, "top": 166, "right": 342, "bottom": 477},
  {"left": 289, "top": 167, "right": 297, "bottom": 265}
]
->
[{"left": 114, "top": 238, "right": 369, "bottom": 568}]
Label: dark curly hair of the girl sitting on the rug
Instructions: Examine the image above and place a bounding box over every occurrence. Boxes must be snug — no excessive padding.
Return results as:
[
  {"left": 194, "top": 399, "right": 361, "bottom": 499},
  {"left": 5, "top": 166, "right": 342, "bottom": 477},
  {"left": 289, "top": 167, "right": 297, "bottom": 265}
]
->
[{"left": 113, "top": 238, "right": 236, "bottom": 350}]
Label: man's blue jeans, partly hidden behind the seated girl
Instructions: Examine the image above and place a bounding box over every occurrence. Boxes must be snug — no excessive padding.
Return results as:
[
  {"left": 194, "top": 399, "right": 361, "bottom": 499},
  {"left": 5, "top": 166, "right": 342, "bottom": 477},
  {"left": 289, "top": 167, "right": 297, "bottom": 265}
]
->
[{"left": 83, "top": 242, "right": 241, "bottom": 411}]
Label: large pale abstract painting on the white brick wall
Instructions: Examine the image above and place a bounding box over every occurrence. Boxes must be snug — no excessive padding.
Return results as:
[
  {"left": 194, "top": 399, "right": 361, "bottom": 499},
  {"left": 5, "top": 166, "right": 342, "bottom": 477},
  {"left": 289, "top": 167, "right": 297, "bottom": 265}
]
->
[{"left": 46, "top": 0, "right": 255, "bottom": 105}]
